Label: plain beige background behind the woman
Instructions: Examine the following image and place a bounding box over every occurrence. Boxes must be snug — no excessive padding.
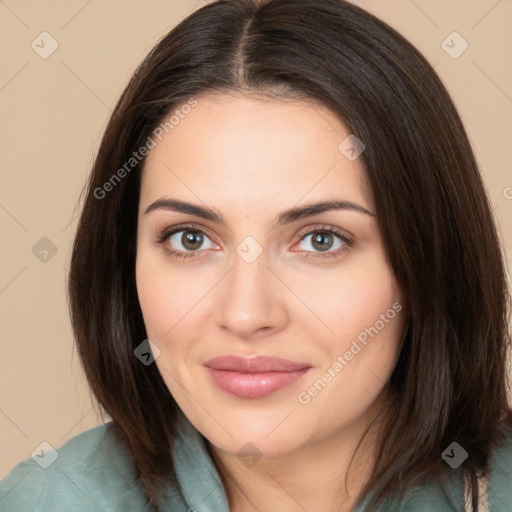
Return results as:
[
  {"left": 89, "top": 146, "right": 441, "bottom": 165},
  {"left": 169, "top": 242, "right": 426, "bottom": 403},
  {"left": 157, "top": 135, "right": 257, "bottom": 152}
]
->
[{"left": 0, "top": 0, "right": 512, "bottom": 477}]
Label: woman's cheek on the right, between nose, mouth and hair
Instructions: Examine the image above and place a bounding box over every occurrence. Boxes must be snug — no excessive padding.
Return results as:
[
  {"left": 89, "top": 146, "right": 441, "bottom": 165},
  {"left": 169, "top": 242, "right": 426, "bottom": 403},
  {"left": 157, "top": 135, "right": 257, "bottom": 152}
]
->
[{"left": 294, "top": 252, "right": 405, "bottom": 404}]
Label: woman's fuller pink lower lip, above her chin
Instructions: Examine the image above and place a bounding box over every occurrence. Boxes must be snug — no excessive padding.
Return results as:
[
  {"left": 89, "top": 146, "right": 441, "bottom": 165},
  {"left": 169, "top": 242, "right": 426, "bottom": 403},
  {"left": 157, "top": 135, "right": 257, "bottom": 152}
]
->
[{"left": 207, "top": 368, "right": 309, "bottom": 398}]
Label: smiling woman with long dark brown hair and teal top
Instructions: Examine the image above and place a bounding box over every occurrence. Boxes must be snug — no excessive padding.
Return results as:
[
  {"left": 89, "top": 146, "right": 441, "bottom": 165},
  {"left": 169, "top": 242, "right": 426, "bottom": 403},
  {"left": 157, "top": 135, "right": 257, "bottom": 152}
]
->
[{"left": 0, "top": 0, "right": 512, "bottom": 512}]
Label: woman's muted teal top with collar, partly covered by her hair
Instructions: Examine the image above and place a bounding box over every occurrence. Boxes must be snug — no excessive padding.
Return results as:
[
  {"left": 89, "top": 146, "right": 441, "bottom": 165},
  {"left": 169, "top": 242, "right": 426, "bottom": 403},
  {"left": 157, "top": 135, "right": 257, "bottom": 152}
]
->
[{"left": 0, "top": 414, "right": 512, "bottom": 512}]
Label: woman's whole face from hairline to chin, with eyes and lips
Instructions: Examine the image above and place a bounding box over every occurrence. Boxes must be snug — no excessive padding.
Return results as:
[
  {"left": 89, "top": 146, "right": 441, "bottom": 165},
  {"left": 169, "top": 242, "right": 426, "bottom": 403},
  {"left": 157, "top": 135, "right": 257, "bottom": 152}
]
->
[{"left": 136, "top": 94, "right": 405, "bottom": 455}]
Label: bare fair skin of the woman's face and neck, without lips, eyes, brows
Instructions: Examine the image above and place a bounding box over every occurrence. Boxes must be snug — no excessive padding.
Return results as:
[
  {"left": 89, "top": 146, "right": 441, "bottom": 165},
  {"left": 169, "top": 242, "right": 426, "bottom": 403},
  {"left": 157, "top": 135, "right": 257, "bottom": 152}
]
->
[{"left": 136, "top": 93, "right": 405, "bottom": 512}]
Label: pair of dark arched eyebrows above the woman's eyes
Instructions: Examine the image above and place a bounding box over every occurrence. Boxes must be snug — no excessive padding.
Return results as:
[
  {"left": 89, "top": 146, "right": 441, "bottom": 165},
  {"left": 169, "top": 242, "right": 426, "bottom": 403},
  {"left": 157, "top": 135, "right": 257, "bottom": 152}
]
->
[{"left": 144, "top": 199, "right": 376, "bottom": 224}]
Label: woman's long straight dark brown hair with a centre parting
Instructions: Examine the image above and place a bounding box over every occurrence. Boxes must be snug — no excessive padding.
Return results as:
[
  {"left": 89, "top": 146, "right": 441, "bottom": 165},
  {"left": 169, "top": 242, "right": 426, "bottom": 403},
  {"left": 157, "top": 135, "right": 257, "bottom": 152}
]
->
[{"left": 68, "top": 0, "right": 512, "bottom": 508}]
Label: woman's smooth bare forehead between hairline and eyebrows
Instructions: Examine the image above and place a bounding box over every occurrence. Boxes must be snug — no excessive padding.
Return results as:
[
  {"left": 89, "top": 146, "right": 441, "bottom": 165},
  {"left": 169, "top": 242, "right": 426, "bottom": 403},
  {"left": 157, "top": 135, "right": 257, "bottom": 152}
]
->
[{"left": 141, "top": 93, "right": 373, "bottom": 215}]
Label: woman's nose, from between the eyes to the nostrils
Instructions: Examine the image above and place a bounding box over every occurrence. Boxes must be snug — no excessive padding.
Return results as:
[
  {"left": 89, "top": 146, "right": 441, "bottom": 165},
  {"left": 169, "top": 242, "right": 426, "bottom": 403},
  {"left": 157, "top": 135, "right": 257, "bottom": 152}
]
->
[{"left": 213, "top": 248, "right": 288, "bottom": 341}]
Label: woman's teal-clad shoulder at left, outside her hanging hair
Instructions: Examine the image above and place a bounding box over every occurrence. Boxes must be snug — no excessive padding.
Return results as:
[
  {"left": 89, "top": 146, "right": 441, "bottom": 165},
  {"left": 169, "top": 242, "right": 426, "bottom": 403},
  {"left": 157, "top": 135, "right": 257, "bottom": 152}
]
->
[{"left": 0, "top": 423, "right": 150, "bottom": 512}]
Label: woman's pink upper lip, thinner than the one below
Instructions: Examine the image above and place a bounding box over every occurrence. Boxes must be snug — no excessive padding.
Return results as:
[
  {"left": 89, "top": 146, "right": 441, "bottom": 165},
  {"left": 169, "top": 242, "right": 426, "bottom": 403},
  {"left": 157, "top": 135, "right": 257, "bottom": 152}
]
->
[{"left": 204, "top": 355, "right": 311, "bottom": 373}]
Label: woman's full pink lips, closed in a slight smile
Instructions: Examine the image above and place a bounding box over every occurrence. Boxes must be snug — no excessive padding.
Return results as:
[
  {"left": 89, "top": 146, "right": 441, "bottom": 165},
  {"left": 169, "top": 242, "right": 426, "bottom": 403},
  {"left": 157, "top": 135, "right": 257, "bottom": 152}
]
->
[{"left": 204, "top": 356, "right": 311, "bottom": 398}]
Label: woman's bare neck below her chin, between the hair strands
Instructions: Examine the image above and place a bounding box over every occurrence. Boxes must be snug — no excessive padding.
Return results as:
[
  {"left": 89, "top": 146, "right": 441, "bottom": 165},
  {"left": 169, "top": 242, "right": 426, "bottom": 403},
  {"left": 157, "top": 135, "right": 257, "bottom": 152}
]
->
[{"left": 209, "top": 402, "right": 386, "bottom": 512}]
